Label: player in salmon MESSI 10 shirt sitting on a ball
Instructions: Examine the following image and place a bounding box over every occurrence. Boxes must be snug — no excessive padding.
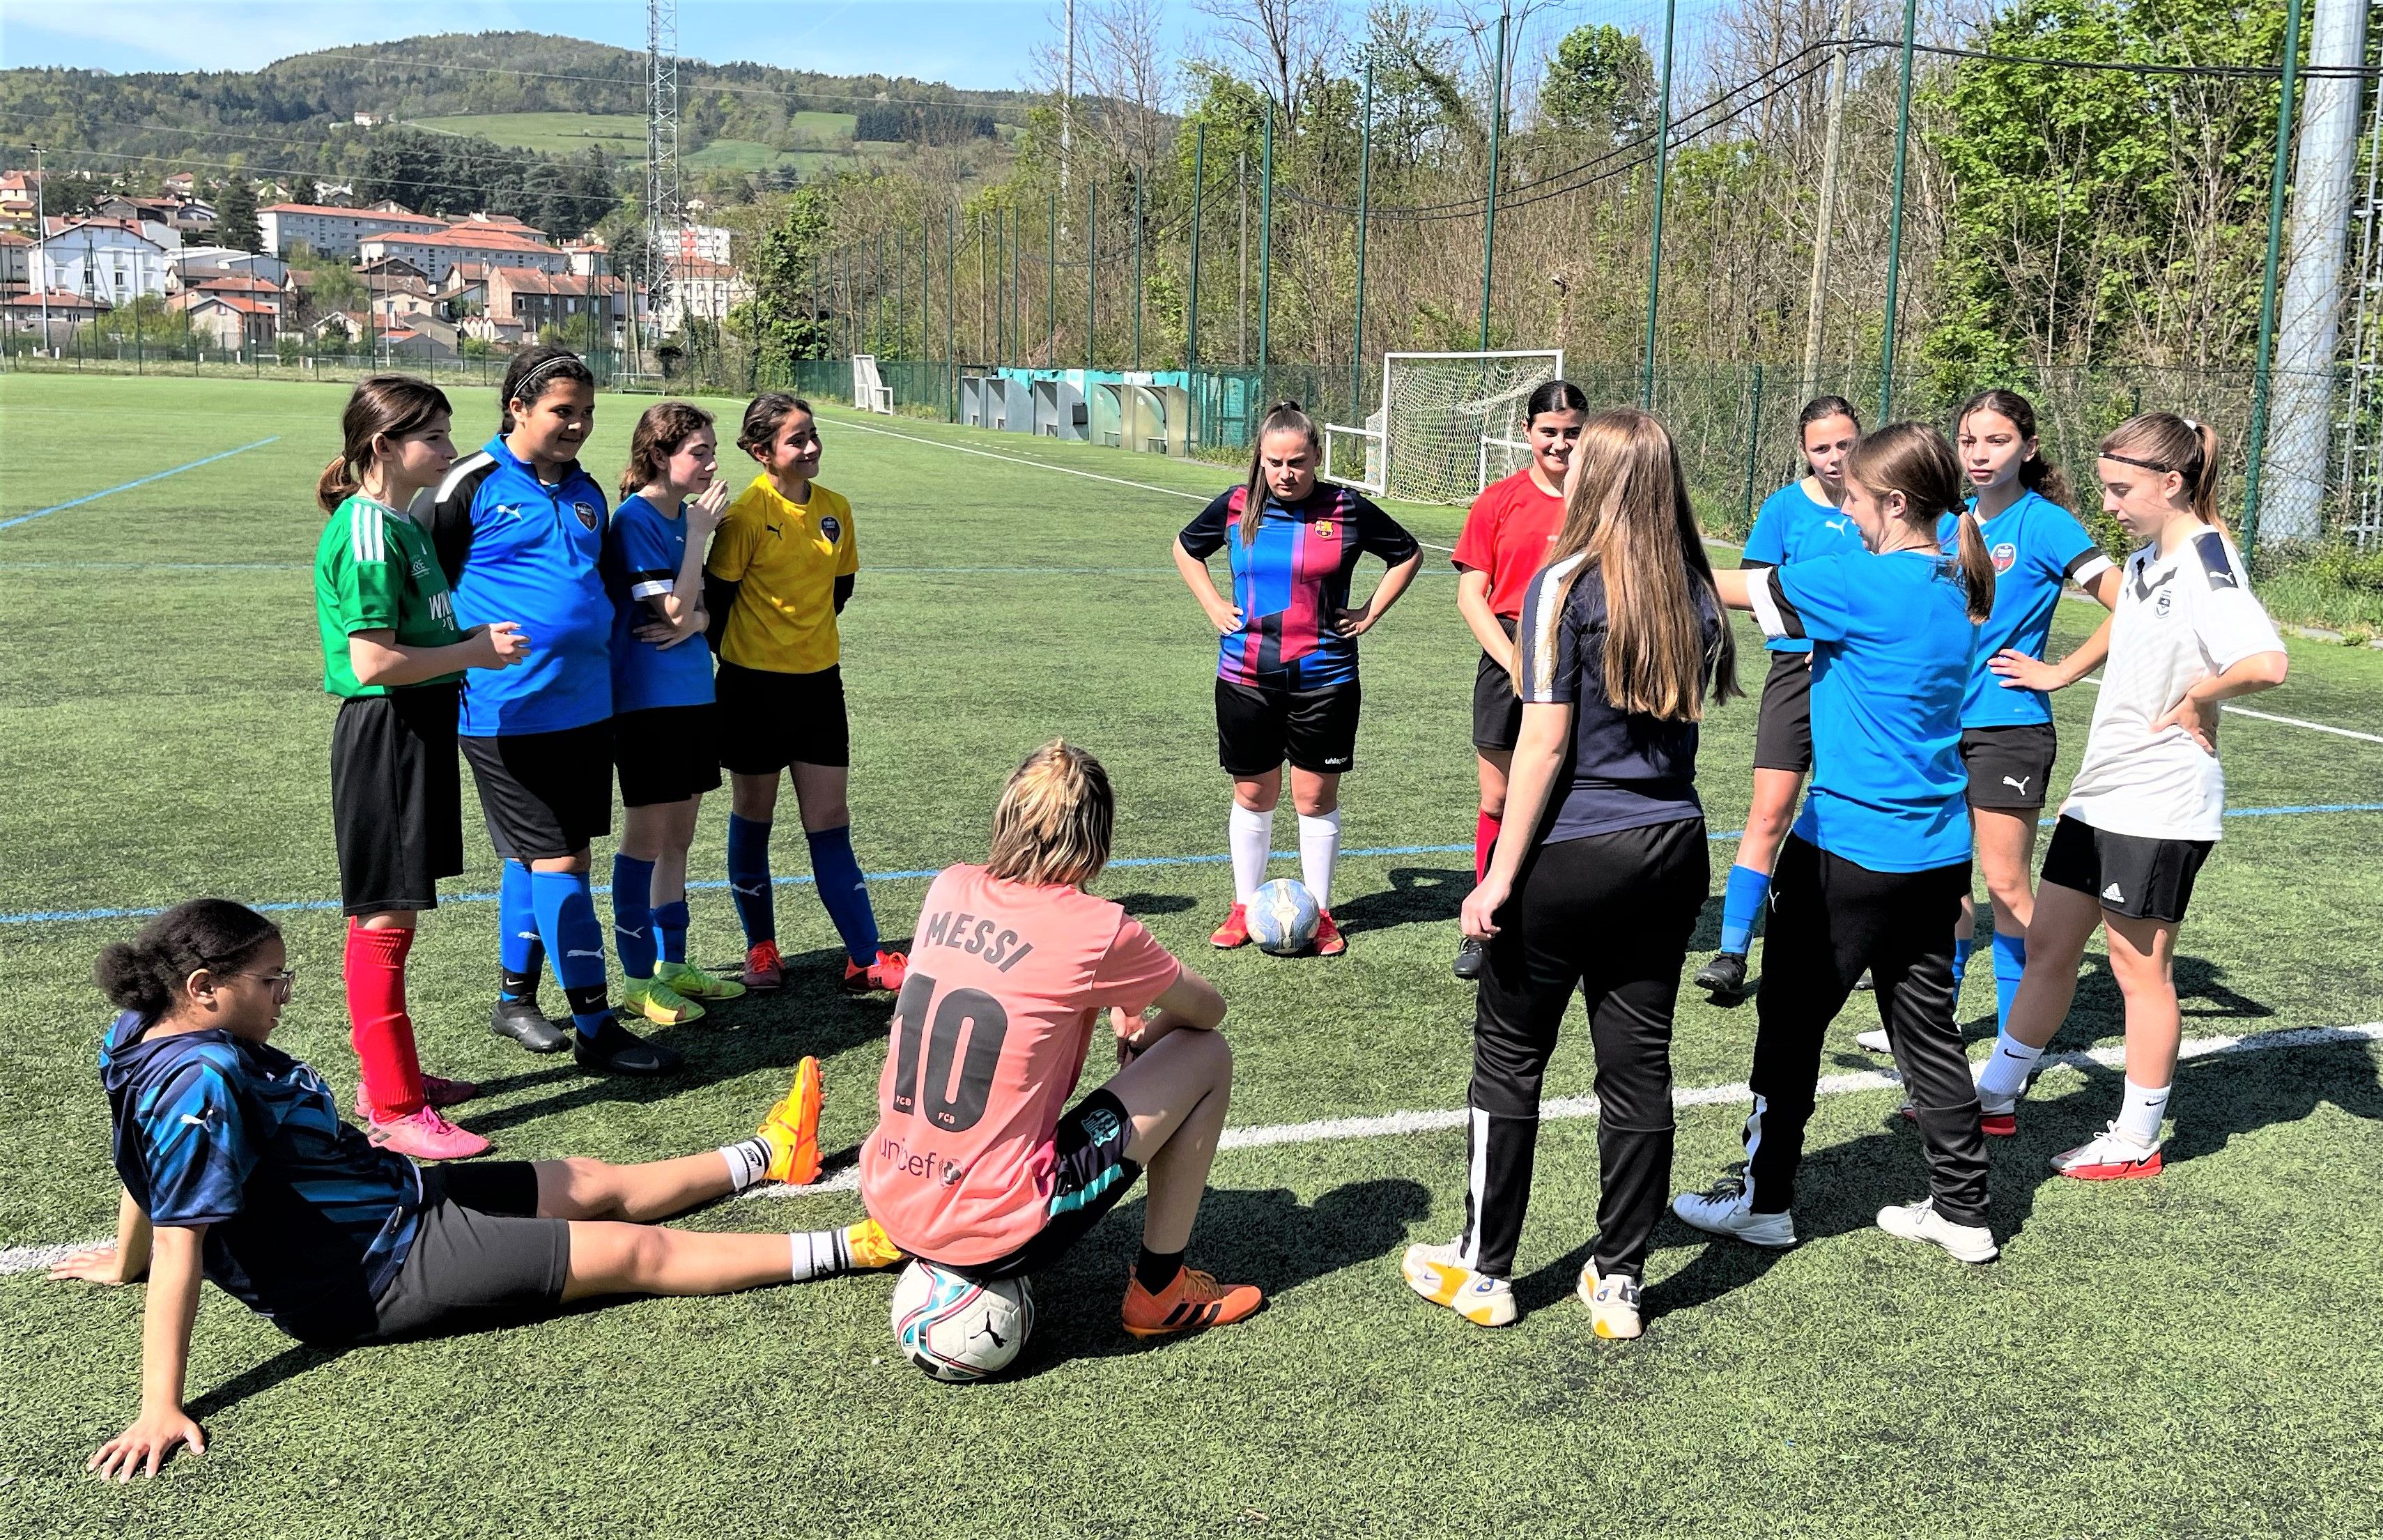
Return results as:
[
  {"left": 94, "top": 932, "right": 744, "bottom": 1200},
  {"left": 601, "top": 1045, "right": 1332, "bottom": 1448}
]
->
[{"left": 861, "top": 741, "right": 1265, "bottom": 1337}]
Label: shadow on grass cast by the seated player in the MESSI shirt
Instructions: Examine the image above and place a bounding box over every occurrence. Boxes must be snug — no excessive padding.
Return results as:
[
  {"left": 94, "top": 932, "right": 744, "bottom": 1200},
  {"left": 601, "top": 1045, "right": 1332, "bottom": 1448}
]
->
[{"left": 1003, "top": 1178, "right": 1432, "bottom": 1380}]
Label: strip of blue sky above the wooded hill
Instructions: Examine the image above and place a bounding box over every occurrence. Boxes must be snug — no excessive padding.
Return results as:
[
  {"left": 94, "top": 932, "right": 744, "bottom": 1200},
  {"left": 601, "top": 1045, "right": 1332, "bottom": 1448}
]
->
[{"left": 0, "top": 0, "right": 1091, "bottom": 91}]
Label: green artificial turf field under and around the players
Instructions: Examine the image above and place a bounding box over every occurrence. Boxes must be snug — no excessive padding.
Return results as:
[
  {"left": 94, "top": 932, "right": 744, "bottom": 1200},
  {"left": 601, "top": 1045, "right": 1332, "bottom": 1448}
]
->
[{"left": 0, "top": 374, "right": 2383, "bottom": 1540}]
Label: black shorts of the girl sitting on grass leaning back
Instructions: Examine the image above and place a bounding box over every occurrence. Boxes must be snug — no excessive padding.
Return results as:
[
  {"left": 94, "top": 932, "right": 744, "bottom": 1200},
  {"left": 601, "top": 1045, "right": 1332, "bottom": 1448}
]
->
[{"left": 372, "top": 1161, "right": 572, "bottom": 1340}]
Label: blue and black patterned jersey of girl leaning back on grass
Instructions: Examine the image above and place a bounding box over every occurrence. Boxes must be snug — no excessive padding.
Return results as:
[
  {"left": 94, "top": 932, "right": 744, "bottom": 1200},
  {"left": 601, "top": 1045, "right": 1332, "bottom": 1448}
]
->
[{"left": 100, "top": 1011, "right": 422, "bottom": 1342}]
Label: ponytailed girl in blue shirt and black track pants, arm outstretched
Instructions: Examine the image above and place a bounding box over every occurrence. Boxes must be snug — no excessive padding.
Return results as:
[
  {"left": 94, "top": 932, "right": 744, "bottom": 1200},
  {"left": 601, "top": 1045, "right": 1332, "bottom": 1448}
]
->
[{"left": 1673, "top": 422, "right": 1995, "bottom": 1261}]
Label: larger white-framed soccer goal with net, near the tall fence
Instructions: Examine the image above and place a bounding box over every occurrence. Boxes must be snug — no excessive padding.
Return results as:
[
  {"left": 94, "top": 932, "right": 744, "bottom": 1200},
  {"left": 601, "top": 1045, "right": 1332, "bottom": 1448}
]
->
[{"left": 1322, "top": 348, "right": 1564, "bottom": 503}]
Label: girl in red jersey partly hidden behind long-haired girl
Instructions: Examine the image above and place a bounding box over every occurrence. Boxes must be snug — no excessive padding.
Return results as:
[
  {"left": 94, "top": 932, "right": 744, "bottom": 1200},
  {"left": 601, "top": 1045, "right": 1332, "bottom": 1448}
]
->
[{"left": 1449, "top": 379, "right": 1589, "bottom": 980}]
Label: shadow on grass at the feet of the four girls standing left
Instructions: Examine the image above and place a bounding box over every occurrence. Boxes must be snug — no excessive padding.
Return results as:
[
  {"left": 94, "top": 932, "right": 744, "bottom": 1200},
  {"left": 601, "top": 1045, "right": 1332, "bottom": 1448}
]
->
[{"left": 460, "top": 946, "right": 894, "bottom": 1137}]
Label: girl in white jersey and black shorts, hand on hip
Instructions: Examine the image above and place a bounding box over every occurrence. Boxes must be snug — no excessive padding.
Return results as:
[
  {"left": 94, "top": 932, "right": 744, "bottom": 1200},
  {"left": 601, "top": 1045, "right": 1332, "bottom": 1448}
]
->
[{"left": 1978, "top": 413, "right": 2285, "bottom": 1180}]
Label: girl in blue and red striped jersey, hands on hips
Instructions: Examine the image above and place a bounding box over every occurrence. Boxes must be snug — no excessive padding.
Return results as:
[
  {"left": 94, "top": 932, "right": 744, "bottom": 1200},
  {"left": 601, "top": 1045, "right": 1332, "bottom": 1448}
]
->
[{"left": 1175, "top": 401, "right": 1423, "bottom": 956}]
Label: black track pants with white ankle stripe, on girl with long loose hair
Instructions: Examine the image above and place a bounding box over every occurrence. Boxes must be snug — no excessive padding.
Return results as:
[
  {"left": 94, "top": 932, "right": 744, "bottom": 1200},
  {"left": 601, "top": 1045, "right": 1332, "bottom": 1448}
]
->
[{"left": 1458, "top": 817, "right": 1711, "bottom": 1278}]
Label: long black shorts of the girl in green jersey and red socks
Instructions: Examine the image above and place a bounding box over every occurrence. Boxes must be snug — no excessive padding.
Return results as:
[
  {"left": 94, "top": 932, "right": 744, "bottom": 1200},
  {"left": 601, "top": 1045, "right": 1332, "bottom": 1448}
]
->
[{"left": 331, "top": 684, "right": 462, "bottom": 916}]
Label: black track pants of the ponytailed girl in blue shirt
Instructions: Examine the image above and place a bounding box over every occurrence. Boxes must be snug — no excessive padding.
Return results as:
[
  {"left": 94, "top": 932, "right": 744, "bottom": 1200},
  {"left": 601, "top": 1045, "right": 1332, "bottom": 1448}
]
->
[{"left": 1747, "top": 834, "right": 1985, "bottom": 1225}]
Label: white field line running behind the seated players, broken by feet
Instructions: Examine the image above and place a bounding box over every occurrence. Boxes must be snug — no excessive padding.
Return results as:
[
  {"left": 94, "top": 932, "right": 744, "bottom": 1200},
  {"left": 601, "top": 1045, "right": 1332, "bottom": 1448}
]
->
[{"left": 0, "top": 1020, "right": 2383, "bottom": 1278}]
